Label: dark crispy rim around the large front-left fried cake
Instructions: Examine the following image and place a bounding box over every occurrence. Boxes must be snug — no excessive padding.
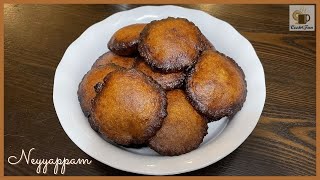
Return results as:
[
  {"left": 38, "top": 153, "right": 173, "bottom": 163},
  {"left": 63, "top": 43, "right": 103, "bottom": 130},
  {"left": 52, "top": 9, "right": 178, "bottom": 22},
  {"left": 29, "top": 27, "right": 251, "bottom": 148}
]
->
[{"left": 89, "top": 68, "right": 167, "bottom": 146}]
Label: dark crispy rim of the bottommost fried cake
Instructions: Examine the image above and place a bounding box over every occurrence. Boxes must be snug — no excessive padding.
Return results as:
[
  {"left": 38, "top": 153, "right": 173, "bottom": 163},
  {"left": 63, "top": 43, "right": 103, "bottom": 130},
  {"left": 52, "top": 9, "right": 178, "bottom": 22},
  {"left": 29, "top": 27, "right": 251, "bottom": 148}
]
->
[{"left": 148, "top": 92, "right": 208, "bottom": 156}]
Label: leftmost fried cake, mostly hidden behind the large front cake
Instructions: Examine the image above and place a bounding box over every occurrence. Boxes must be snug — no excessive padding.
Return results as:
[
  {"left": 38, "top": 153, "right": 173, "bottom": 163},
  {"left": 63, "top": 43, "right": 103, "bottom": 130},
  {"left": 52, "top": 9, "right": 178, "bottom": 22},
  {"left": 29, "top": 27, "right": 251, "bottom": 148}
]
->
[{"left": 78, "top": 64, "right": 121, "bottom": 116}]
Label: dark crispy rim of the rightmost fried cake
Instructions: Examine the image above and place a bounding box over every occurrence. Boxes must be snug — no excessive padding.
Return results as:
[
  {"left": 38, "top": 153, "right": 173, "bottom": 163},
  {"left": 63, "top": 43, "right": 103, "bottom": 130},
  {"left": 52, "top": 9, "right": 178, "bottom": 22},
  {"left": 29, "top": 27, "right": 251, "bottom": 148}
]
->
[{"left": 185, "top": 51, "right": 248, "bottom": 122}]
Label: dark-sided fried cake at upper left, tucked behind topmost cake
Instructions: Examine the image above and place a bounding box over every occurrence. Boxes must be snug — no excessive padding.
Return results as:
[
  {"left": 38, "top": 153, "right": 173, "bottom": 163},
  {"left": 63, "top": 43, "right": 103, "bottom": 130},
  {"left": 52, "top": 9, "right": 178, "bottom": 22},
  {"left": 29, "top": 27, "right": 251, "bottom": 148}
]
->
[{"left": 108, "top": 24, "right": 146, "bottom": 56}]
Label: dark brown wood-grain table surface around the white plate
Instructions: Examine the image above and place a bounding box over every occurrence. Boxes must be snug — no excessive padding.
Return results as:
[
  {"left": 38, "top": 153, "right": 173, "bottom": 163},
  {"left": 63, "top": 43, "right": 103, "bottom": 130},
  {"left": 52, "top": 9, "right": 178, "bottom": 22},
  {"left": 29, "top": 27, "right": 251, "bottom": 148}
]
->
[{"left": 4, "top": 5, "right": 316, "bottom": 175}]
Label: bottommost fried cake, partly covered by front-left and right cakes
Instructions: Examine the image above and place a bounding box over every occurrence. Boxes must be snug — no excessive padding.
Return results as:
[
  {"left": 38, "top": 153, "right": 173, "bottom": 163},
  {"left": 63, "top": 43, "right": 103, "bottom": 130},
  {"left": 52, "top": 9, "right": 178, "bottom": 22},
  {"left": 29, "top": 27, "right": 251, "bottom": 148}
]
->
[{"left": 149, "top": 89, "right": 208, "bottom": 156}]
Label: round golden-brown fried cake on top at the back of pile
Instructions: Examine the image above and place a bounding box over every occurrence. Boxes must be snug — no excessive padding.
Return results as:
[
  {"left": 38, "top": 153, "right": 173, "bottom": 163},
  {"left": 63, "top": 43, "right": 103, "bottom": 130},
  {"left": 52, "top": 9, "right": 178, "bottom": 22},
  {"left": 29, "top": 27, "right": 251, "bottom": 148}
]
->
[{"left": 138, "top": 17, "right": 203, "bottom": 72}]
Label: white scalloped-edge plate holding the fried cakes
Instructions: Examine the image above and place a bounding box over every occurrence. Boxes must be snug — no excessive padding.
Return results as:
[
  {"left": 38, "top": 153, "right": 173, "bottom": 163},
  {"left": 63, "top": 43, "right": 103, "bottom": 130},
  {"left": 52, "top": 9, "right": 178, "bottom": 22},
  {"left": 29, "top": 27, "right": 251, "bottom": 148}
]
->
[{"left": 53, "top": 6, "right": 266, "bottom": 175}]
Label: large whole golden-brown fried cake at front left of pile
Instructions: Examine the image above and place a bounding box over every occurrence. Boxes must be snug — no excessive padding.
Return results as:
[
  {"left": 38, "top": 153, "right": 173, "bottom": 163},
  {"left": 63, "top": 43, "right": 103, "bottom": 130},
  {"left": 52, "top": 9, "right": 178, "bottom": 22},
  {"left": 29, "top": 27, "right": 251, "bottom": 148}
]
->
[{"left": 90, "top": 69, "right": 167, "bottom": 146}]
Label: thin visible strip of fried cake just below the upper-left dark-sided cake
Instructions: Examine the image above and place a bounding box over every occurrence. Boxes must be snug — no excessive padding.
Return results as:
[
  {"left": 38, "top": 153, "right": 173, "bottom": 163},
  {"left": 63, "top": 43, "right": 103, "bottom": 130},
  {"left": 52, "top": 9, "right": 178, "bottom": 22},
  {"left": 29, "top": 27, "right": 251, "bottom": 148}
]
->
[{"left": 92, "top": 51, "right": 135, "bottom": 69}]
